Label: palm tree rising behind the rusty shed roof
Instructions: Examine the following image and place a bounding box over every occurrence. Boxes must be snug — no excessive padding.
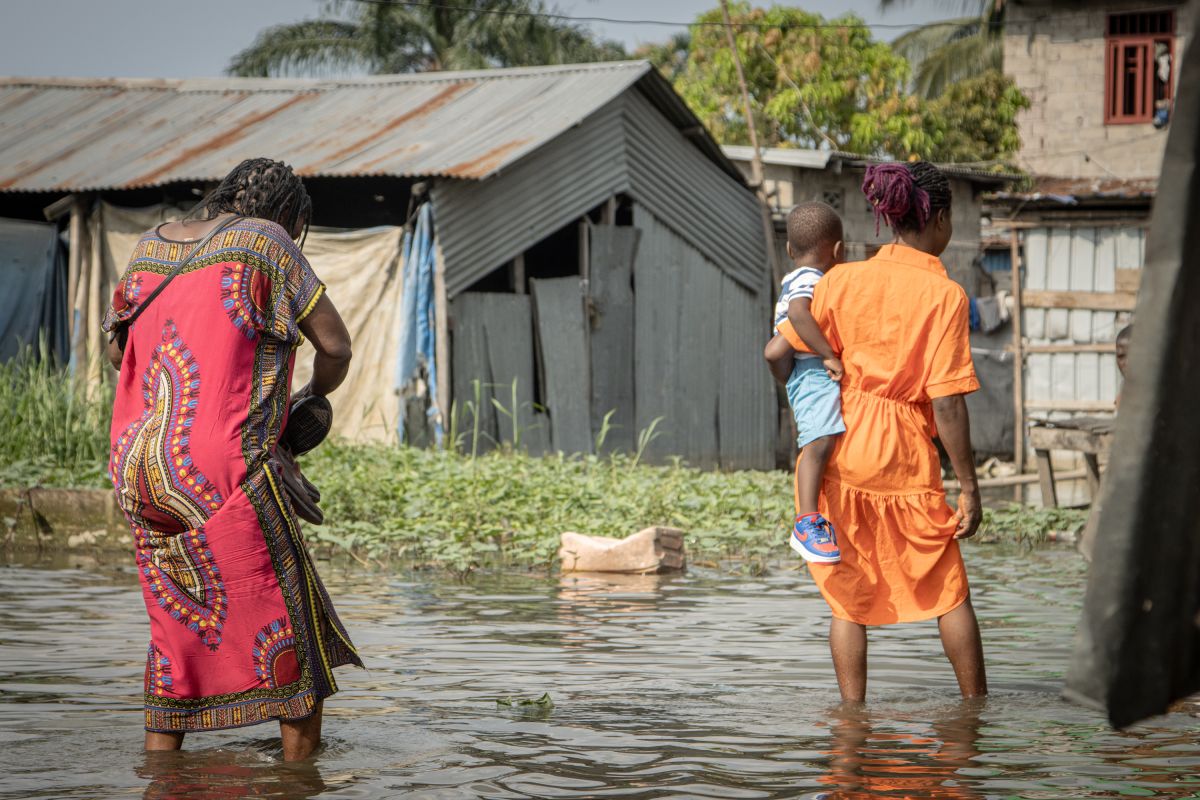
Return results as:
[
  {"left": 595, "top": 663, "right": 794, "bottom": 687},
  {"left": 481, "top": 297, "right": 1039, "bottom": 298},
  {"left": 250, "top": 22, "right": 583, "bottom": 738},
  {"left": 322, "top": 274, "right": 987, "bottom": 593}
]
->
[{"left": 228, "top": 0, "right": 625, "bottom": 77}]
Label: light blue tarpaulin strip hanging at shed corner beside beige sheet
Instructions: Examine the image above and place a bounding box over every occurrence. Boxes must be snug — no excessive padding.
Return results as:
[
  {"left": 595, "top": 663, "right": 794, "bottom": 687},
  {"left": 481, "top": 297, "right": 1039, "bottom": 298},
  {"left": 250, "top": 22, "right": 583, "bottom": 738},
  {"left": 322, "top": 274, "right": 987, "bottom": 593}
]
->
[{"left": 396, "top": 203, "right": 442, "bottom": 445}]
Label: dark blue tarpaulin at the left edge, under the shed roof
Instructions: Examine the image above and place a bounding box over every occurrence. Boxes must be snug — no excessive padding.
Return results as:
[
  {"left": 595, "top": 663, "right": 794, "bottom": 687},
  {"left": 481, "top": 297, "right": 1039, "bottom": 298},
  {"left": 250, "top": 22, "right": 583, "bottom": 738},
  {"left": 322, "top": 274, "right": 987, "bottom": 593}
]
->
[{"left": 0, "top": 218, "right": 68, "bottom": 363}]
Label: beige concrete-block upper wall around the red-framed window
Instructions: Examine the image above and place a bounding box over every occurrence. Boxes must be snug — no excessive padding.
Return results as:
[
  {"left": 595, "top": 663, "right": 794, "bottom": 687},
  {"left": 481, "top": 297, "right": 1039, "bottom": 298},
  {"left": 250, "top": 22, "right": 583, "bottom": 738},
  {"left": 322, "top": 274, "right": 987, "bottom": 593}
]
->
[{"left": 1004, "top": 0, "right": 1194, "bottom": 179}]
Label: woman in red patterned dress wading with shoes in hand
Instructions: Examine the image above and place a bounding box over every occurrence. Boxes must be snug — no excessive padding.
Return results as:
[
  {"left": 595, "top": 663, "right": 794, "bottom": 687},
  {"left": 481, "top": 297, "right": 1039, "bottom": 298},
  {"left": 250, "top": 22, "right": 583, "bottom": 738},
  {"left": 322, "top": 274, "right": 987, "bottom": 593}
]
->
[{"left": 104, "top": 158, "right": 361, "bottom": 760}]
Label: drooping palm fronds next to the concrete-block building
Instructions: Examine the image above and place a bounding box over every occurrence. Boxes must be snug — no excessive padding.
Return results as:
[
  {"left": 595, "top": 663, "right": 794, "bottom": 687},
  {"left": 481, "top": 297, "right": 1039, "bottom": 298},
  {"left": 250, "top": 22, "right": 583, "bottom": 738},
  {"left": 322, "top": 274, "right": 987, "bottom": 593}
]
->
[{"left": 880, "top": 0, "right": 1004, "bottom": 98}]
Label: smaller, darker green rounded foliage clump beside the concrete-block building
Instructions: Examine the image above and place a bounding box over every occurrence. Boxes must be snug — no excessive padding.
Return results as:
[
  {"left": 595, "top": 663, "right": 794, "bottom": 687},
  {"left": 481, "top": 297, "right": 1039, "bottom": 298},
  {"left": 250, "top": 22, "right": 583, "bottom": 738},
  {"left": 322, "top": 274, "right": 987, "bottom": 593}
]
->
[{"left": 930, "top": 70, "right": 1030, "bottom": 162}]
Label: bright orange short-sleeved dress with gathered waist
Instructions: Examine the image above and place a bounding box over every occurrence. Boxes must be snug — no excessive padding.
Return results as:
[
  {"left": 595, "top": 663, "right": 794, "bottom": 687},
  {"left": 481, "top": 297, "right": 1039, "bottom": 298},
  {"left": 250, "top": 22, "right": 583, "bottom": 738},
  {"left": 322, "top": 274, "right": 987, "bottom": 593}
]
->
[{"left": 780, "top": 245, "right": 979, "bottom": 625}]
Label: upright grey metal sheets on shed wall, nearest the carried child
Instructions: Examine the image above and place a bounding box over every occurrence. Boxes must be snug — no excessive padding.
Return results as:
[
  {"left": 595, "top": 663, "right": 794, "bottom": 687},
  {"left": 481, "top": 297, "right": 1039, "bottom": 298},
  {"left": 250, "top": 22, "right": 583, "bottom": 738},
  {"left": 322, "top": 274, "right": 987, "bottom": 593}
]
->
[{"left": 634, "top": 205, "right": 776, "bottom": 469}]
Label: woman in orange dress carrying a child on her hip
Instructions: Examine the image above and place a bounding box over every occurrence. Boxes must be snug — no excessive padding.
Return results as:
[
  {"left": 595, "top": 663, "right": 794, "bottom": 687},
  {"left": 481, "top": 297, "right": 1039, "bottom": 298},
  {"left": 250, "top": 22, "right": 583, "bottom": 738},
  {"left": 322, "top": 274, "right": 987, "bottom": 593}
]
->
[{"left": 782, "top": 162, "right": 988, "bottom": 702}]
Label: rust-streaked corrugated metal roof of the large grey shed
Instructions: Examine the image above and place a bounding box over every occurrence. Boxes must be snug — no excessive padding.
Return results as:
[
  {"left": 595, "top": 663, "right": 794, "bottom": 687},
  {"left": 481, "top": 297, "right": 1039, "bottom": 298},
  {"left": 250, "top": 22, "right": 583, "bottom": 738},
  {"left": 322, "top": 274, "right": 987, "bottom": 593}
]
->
[{"left": 0, "top": 61, "right": 705, "bottom": 192}]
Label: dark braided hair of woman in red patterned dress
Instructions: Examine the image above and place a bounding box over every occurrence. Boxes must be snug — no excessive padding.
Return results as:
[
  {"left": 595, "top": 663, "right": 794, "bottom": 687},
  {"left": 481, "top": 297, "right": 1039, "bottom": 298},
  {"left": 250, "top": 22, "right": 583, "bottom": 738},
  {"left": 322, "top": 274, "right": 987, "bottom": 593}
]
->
[{"left": 188, "top": 158, "right": 312, "bottom": 247}]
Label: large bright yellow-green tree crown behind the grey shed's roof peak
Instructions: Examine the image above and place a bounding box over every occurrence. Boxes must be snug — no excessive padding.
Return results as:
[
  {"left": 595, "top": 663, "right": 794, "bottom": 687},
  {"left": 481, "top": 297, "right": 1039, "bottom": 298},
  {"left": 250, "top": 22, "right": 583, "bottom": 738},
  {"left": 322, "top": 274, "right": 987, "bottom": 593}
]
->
[{"left": 674, "top": 2, "right": 936, "bottom": 156}]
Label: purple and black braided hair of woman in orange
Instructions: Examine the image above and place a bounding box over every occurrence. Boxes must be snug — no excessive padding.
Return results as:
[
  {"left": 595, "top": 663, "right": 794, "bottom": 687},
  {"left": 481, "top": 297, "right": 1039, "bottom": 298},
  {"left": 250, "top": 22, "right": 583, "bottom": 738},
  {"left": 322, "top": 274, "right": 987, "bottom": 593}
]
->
[{"left": 863, "top": 161, "right": 952, "bottom": 234}]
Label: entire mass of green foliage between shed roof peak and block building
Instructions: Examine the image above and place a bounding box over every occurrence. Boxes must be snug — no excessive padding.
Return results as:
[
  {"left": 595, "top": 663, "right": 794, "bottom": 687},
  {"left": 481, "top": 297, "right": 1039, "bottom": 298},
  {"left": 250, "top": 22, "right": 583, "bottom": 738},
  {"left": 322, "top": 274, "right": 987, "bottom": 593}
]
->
[{"left": 662, "top": 2, "right": 1028, "bottom": 162}]
